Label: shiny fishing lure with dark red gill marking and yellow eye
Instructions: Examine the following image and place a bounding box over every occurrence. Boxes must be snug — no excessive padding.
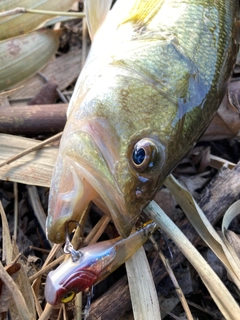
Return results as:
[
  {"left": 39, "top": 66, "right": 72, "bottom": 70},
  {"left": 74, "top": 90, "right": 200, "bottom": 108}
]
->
[{"left": 44, "top": 222, "right": 157, "bottom": 305}]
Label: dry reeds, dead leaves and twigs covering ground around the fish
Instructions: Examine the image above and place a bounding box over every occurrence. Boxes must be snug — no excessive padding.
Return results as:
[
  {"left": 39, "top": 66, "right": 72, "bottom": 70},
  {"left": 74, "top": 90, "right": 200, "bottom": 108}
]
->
[{"left": 0, "top": 1, "right": 240, "bottom": 320}]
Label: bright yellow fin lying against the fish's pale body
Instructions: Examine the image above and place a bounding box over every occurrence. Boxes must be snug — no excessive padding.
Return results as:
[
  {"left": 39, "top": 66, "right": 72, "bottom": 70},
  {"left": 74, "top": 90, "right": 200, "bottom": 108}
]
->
[{"left": 122, "top": 0, "right": 164, "bottom": 25}]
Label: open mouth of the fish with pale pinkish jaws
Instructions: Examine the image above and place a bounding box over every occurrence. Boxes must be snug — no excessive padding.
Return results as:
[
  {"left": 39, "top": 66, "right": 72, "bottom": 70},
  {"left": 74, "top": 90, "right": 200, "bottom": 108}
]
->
[{"left": 46, "top": 124, "right": 138, "bottom": 243}]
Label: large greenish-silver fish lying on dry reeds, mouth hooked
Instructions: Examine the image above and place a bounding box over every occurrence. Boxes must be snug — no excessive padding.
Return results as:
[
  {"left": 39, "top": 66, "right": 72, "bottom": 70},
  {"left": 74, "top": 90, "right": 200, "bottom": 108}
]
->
[{"left": 46, "top": 0, "right": 239, "bottom": 243}]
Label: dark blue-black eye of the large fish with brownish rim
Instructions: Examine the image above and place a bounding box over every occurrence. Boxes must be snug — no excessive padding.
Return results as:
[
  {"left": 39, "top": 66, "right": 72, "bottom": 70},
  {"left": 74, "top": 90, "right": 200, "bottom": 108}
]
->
[{"left": 132, "top": 138, "right": 161, "bottom": 172}]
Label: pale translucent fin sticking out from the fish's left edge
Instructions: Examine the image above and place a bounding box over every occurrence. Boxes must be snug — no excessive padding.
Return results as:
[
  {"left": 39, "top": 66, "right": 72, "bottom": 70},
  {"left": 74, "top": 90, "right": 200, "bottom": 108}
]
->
[{"left": 84, "top": 0, "right": 112, "bottom": 40}]
